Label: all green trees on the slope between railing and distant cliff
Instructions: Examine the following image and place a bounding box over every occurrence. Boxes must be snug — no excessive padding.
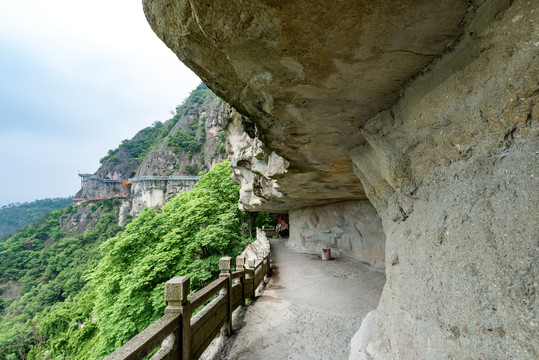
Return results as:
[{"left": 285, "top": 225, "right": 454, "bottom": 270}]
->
[{"left": 0, "top": 162, "right": 268, "bottom": 360}]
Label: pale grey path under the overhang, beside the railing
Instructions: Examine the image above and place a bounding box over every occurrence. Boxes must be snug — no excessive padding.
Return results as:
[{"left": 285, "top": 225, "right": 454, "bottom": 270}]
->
[{"left": 209, "top": 239, "right": 385, "bottom": 360}]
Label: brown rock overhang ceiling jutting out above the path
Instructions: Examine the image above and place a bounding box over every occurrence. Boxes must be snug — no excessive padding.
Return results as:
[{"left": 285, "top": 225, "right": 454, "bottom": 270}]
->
[{"left": 143, "top": 0, "right": 470, "bottom": 211}]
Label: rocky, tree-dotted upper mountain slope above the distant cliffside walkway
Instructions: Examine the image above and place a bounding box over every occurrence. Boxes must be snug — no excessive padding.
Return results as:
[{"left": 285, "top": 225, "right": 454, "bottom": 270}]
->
[{"left": 83, "top": 83, "right": 225, "bottom": 191}]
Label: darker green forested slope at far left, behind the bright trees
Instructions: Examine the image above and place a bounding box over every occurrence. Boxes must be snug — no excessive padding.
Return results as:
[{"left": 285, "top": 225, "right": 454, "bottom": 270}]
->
[{"left": 0, "top": 203, "right": 119, "bottom": 360}]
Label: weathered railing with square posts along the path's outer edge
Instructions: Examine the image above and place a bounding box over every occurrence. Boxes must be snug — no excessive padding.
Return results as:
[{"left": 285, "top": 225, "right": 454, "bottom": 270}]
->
[{"left": 105, "top": 231, "right": 270, "bottom": 360}]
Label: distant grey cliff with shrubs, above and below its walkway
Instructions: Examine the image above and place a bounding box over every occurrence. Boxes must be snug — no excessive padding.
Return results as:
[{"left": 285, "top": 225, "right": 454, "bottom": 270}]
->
[{"left": 75, "top": 84, "right": 226, "bottom": 219}]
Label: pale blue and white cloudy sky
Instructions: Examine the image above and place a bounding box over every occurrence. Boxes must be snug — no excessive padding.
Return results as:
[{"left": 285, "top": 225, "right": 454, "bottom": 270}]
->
[{"left": 0, "top": 0, "right": 200, "bottom": 206}]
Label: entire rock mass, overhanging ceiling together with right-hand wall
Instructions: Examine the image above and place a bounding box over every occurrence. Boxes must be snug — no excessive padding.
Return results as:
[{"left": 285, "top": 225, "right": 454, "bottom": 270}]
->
[{"left": 143, "top": 0, "right": 539, "bottom": 359}]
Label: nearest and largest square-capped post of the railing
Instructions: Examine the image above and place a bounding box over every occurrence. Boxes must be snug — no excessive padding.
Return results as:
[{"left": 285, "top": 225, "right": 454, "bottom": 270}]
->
[{"left": 165, "top": 276, "right": 191, "bottom": 360}]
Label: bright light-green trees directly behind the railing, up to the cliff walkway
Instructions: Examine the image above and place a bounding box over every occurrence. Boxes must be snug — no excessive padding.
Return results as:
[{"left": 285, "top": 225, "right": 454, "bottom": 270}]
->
[{"left": 19, "top": 162, "right": 252, "bottom": 360}]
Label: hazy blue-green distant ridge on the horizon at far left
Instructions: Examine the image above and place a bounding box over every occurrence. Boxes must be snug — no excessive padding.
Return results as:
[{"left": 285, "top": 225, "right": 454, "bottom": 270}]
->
[{"left": 0, "top": 197, "right": 73, "bottom": 239}]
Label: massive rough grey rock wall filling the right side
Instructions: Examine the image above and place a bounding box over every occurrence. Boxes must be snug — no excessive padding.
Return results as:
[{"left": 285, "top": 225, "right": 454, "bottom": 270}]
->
[{"left": 351, "top": 1, "right": 539, "bottom": 359}]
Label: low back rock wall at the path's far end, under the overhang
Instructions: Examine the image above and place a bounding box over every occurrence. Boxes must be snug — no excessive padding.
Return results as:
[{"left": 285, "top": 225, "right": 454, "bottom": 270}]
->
[{"left": 287, "top": 200, "right": 385, "bottom": 267}]
